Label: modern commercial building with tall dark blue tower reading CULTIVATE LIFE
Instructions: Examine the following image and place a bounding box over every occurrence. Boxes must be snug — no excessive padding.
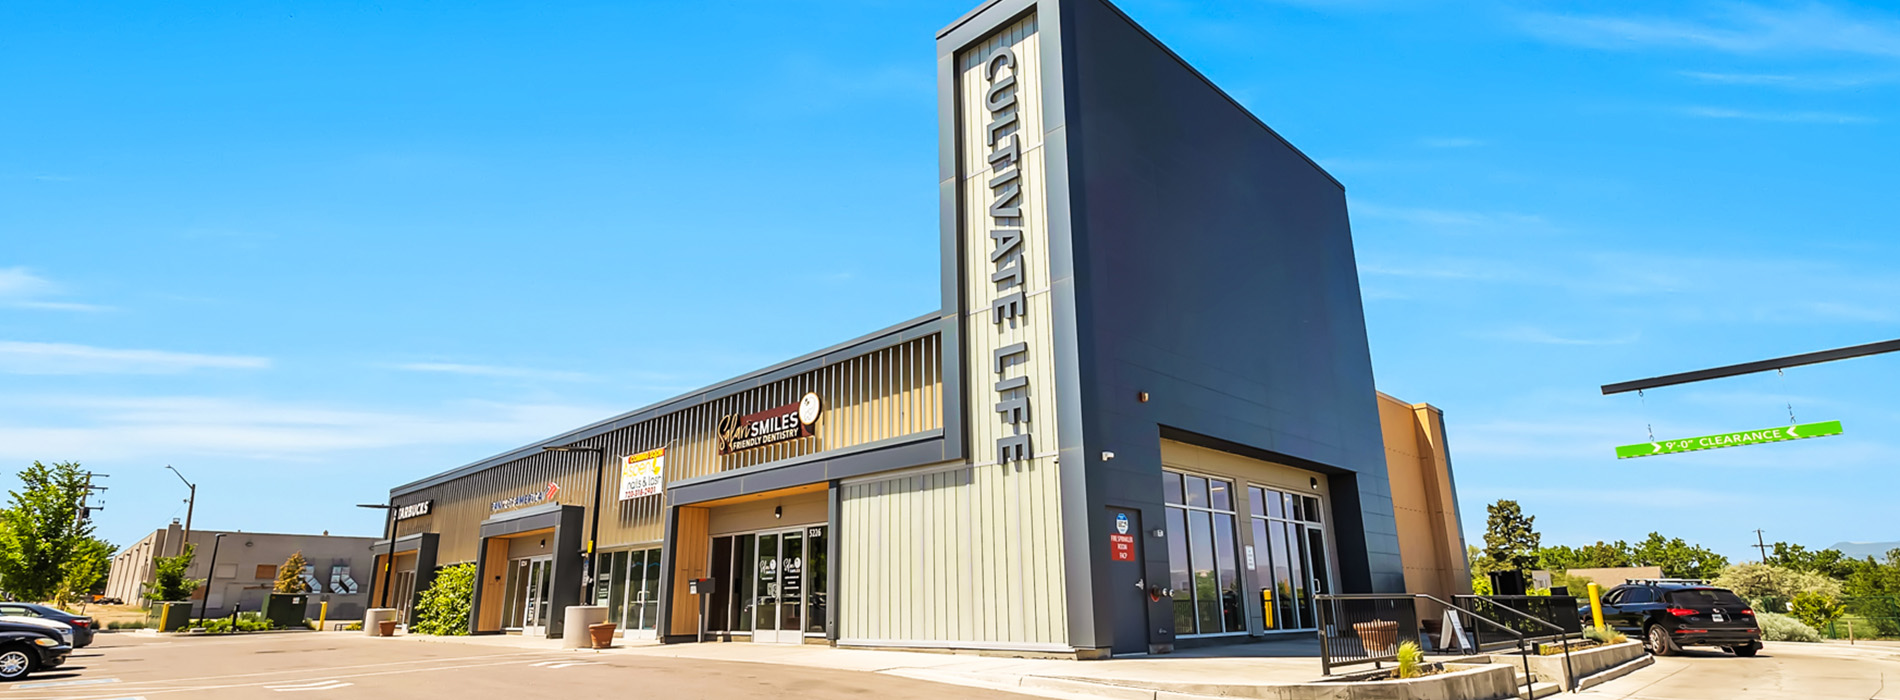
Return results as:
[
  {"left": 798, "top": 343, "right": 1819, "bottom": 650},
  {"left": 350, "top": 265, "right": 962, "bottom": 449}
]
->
[{"left": 378, "top": 0, "right": 1469, "bottom": 658}]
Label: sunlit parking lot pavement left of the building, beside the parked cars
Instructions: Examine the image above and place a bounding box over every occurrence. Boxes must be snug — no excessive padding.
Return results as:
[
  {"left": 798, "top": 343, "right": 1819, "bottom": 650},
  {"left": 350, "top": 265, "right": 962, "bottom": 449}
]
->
[{"left": 0, "top": 633, "right": 1024, "bottom": 700}]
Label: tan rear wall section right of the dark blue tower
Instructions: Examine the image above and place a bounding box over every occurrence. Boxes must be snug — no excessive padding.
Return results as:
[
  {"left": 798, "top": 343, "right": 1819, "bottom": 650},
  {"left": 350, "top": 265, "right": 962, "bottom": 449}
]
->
[{"left": 1379, "top": 394, "right": 1471, "bottom": 599}]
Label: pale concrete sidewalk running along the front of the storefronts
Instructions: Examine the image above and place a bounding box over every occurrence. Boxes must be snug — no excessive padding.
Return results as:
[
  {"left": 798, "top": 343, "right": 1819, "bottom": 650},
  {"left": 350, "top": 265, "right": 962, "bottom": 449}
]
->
[{"left": 378, "top": 635, "right": 1345, "bottom": 698}]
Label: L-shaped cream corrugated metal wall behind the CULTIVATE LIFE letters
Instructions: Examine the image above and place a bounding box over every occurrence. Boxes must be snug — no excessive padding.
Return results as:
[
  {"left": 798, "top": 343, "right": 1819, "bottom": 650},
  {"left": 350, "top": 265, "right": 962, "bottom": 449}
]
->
[{"left": 838, "top": 15, "right": 1070, "bottom": 651}]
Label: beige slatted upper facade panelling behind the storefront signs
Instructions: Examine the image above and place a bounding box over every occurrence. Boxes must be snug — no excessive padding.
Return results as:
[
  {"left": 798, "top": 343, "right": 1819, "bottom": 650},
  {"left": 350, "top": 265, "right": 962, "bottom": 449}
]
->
[{"left": 397, "top": 335, "right": 942, "bottom": 563}]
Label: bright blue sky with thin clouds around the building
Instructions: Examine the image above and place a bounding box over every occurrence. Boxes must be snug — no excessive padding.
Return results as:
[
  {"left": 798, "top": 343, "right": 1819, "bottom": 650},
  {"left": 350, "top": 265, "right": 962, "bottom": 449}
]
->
[{"left": 0, "top": 0, "right": 1900, "bottom": 557}]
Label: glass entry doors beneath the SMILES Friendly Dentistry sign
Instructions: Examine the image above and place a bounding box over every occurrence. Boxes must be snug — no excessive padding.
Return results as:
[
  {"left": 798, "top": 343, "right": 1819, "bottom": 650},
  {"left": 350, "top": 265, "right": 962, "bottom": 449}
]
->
[{"left": 709, "top": 527, "right": 827, "bottom": 643}]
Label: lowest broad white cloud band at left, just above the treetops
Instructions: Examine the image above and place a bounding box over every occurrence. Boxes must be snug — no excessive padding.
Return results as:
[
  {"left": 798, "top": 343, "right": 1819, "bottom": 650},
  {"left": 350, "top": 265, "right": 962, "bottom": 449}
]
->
[{"left": 0, "top": 396, "right": 608, "bottom": 462}]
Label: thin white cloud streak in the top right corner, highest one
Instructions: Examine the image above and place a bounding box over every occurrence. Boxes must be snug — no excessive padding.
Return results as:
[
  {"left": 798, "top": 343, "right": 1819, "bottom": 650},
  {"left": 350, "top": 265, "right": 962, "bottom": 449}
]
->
[{"left": 1522, "top": 2, "right": 1900, "bottom": 57}]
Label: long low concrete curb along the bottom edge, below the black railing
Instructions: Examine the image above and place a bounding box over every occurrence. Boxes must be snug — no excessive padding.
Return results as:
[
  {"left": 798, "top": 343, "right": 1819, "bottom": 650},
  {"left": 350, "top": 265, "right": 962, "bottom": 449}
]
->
[{"left": 1020, "top": 664, "right": 1518, "bottom": 700}]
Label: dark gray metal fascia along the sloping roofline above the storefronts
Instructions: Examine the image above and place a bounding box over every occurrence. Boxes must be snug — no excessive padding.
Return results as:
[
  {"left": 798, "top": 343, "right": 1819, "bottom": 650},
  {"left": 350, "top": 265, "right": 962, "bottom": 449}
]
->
[{"left": 390, "top": 312, "right": 950, "bottom": 498}]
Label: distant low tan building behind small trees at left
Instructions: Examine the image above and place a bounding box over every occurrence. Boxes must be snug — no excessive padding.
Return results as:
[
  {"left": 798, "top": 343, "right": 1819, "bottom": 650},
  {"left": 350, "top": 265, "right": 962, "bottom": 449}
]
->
[{"left": 106, "top": 519, "right": 376, "bottom": 618}]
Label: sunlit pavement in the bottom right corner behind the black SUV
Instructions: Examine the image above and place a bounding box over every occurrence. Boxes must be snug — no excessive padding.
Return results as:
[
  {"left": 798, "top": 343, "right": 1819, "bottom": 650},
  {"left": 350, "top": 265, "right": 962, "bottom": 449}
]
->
[{"left": 1579, "top": 641, "right": 1900, "bottom": 700}]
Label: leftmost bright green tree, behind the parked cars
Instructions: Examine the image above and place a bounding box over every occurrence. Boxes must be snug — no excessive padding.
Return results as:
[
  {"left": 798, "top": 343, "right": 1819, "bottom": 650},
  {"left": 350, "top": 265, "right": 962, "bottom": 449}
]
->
[{"left": 0, "top": 462, "right": 110, "bottom": 601}]
